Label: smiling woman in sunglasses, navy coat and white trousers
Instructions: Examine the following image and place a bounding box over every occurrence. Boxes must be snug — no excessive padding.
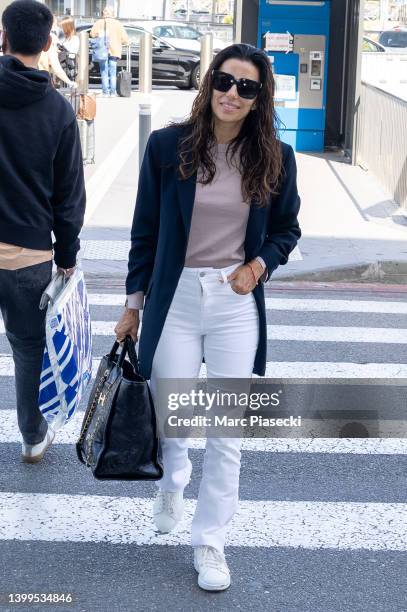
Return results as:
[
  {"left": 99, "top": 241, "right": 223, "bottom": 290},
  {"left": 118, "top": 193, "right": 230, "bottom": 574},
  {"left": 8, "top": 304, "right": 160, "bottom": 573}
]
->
[{"left": 115, "top": 44, "right": 301, "bottom": 590}]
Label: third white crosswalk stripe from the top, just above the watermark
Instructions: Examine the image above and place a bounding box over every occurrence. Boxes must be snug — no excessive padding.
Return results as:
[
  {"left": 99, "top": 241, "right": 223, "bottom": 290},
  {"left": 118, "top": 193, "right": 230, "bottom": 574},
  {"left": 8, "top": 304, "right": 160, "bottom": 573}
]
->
[{"left": 0, "top": 354, "right": 407, "bottom": 379}]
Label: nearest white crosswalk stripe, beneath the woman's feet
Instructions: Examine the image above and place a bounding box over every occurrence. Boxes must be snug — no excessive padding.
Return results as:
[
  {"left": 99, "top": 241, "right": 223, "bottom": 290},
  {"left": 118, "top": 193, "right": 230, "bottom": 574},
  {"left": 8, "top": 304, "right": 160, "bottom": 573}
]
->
[{"left": 0, "top": 492, "right": 407, "bottom": 551}]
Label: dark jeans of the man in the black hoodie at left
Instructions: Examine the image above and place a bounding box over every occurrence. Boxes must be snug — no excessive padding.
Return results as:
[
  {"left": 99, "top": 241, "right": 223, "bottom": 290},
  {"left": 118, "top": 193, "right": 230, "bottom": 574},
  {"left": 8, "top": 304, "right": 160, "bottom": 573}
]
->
[{"left": 0, "top": 261, "right": 52, "bottom": 444}]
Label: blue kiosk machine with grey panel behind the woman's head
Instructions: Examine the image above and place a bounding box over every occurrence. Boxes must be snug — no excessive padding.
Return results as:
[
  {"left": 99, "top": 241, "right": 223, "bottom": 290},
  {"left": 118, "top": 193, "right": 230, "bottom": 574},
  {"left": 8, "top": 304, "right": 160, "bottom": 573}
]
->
[{"left": 257, "top": 0, "right": 331, "bottom": 151}]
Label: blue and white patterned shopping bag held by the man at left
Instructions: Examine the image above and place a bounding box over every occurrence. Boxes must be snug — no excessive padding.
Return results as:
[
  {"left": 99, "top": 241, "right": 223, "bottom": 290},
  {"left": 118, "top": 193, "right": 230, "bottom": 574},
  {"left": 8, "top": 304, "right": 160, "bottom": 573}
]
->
[{"left": 39, "top": 268, "right": 92, "bottom": 430}]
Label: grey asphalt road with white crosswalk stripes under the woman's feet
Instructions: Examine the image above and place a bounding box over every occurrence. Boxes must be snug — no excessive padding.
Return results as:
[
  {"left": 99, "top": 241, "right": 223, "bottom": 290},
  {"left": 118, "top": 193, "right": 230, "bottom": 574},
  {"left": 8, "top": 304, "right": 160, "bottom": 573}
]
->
[{"left": 0, "top": 283, "right": 407, "bottom": 612}]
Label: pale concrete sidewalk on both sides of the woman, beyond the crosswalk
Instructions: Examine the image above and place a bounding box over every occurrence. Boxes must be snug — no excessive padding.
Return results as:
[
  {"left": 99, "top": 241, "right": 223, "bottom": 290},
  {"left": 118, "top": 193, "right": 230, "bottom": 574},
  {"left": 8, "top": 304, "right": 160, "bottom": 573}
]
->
[{"left": 82, "top": 89, "right": 407, "bottom": 283}]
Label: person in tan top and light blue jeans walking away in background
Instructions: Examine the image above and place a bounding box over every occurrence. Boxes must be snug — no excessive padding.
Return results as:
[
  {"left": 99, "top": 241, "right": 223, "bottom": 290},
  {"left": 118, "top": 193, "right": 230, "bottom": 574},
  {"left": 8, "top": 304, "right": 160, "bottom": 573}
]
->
[{"left": 90, "top": 7, "right": 129, "bottom": 97}]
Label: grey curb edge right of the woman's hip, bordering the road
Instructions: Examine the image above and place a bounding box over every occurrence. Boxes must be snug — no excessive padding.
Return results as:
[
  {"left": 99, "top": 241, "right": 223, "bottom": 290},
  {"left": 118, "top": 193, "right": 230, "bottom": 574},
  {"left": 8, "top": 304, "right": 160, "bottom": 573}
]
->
[{"left": 276, "top": 260, "right": 407, "bottom": 285}]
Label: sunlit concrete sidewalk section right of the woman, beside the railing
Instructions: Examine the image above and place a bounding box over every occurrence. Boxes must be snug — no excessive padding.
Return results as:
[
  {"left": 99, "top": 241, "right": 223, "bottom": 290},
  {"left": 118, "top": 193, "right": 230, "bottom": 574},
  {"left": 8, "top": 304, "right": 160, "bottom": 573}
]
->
[{"left": 275, "top": 148, "right": 407, "bottom": 282}]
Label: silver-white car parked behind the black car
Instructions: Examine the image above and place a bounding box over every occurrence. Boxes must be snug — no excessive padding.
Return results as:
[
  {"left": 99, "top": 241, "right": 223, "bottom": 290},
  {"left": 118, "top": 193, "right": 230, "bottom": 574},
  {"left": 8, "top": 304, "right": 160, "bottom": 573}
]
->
[{"left": 137, "top": 20, "right": 230, "bottom": 53}]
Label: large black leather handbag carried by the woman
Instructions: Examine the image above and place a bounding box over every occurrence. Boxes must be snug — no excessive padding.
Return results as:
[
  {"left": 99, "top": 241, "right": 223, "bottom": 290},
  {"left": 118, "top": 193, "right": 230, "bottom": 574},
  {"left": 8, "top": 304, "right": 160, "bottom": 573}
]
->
[{"left": 76, "top": 336, "right": 163, "bottom": 480}]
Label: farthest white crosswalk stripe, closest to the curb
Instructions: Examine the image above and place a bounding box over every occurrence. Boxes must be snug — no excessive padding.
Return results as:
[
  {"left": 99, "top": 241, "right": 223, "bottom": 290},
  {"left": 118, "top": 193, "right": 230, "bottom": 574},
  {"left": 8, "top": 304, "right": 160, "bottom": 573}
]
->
[{"left": 88, "top": 292, "right": 407, "bottom": 314}]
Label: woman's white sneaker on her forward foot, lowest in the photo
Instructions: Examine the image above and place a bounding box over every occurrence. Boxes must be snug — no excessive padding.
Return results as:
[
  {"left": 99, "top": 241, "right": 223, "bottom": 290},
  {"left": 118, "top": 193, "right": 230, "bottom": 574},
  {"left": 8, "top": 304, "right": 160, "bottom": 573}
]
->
[{"left": 194, "top": 546, "right": 230, "bottom": 591}]
